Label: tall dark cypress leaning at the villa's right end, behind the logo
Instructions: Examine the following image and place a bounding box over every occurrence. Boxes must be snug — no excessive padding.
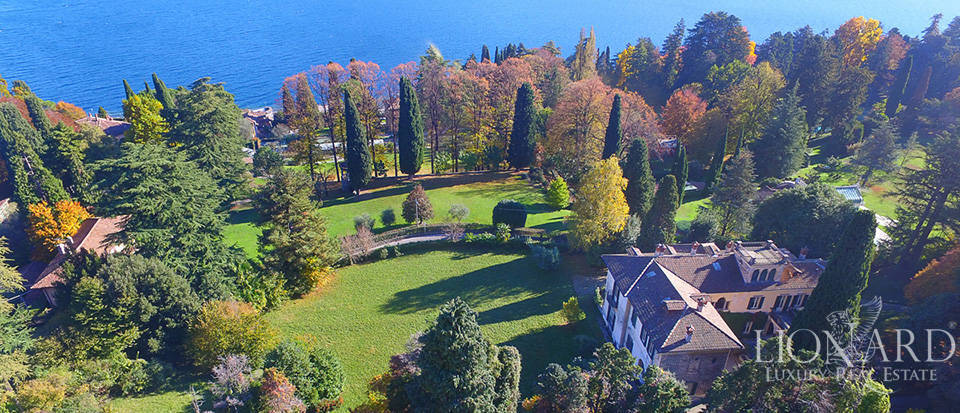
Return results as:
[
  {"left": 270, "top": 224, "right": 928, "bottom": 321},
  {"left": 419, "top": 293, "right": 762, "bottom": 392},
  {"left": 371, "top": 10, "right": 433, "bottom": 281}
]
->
[{"left": 790, "top": 210, "right": 877, "bottom": 350}]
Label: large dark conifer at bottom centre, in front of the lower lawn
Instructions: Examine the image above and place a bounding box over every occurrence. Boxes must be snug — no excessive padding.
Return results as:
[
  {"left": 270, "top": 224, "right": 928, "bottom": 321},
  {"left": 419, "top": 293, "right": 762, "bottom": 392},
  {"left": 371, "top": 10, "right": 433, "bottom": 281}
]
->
[{"left": 407, "top": 297, "right": 502, "bottom": 413}]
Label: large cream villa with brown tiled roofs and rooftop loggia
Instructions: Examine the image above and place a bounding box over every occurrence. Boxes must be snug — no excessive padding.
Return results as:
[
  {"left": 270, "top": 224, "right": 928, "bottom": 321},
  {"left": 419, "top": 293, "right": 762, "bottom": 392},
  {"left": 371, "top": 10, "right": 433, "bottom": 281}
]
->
[{"left": 601, "top": 241, "right": 824, "bottom": 395}]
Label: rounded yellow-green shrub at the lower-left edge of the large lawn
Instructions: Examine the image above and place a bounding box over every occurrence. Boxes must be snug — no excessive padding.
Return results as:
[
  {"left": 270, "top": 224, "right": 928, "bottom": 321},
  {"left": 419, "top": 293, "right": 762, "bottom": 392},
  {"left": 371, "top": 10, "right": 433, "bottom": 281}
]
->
[{"left": 187, "top": 301, "right": 276, "bottom": 370}]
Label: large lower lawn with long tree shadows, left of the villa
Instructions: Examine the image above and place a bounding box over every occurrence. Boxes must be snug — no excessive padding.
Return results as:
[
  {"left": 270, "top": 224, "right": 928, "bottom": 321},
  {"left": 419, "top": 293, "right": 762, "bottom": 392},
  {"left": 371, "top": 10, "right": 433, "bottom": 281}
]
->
[{"left": 267, "top": 246, "right": 599, "bottom": 407}]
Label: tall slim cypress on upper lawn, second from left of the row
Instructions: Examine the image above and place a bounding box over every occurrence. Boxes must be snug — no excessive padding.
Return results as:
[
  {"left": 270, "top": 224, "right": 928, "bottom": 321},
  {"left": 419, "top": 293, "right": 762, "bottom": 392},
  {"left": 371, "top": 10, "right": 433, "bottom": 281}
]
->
[{"left": 397, "top": 77, "right": 423, "bottom": 175}]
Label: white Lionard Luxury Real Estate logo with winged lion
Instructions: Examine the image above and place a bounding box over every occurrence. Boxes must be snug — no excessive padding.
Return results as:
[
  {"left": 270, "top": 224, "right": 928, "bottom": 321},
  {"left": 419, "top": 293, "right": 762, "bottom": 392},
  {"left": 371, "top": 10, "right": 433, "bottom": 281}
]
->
[{"left": 754, "top": 297, "right": 957, "bottom": 382}]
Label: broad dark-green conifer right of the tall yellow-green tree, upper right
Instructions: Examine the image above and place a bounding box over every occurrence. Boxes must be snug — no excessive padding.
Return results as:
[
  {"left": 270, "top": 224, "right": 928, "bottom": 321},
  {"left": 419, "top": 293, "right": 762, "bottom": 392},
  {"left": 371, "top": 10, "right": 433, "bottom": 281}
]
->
[{"left": 750, "top": 86, "right": 807, "bottom": 179}]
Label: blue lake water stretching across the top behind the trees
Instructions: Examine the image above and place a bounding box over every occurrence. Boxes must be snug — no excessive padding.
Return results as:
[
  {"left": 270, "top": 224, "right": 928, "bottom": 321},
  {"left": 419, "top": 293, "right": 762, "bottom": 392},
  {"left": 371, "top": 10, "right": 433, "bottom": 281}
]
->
[{"left": 0, "top": 0, "right": 960, "bottom": 111}]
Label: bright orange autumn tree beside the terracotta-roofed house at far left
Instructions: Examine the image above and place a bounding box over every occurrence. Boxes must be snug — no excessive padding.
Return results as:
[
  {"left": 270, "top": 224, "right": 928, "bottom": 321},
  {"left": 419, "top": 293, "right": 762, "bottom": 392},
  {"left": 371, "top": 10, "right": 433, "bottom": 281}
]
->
[{"left": 27, "top": 200, "right": 91, "bottom": 252}]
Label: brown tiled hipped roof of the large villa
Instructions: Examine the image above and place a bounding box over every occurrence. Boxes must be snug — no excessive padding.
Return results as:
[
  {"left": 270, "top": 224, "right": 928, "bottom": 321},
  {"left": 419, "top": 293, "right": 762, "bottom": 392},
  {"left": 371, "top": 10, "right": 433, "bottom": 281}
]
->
[{"left": 602, "top": 242, "right": 823, "bottom": 353}]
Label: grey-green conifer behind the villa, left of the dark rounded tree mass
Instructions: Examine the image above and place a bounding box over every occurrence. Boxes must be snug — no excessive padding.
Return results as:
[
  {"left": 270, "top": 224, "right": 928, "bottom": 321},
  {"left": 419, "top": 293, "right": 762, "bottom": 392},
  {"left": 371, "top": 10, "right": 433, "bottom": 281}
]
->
[{"left": 710, "top": 151, "right": 757, "bottom": 239}]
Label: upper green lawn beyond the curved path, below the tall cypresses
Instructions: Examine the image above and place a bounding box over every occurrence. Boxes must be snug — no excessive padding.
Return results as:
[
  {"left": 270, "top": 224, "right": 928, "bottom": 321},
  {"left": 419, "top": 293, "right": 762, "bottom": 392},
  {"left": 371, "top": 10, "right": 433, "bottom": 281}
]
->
[{"left": 224, "top": 176, "right": 570, "bottom": 257}]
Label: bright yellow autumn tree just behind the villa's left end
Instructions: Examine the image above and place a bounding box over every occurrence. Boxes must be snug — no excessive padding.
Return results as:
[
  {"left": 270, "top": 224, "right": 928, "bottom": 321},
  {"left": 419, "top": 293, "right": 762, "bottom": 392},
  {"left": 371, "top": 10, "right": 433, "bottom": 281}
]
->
[{"left": 571, "top": 156, "right": 630, "bottom": 249}]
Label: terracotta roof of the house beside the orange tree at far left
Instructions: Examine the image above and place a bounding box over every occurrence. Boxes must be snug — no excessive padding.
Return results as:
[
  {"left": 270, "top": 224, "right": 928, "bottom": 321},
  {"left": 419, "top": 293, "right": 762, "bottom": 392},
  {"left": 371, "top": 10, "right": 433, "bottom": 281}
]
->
[{"left": 30, "top": 217, "right": 123, "bottom": 290}]
